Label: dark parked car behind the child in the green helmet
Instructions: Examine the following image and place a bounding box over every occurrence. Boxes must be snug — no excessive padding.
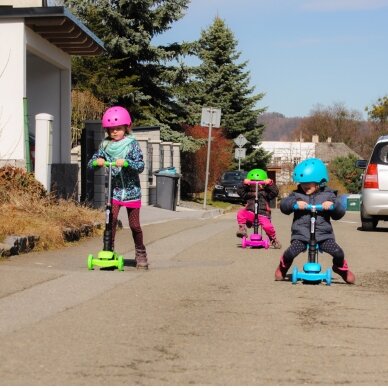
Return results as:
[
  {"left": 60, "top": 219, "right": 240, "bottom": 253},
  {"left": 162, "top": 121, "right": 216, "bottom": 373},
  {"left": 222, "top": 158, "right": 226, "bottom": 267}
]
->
[{"left": 212, "top": 171, "right": 247, "bottom": 202}]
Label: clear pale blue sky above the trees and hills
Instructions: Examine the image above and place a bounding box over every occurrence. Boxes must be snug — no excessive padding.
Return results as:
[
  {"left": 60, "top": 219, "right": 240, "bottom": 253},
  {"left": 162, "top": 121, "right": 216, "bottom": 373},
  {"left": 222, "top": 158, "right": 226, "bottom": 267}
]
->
[{"left": 155, "top": 0, "right": 388, "bottom": 119}]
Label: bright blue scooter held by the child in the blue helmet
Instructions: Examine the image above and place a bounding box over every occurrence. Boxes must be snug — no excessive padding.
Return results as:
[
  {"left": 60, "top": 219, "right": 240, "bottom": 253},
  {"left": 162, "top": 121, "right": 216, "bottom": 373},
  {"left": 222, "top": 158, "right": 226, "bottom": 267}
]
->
[{"left": 291, "top": 204, "right": 334, "bottom": 286}]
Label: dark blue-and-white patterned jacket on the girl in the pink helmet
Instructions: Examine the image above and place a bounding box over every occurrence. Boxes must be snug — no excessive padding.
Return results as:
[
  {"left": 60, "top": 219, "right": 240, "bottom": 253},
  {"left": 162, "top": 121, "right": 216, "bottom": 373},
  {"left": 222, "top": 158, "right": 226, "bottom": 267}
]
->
[{"left": 88, "top": 140, "right": 144, "bottom": 201}]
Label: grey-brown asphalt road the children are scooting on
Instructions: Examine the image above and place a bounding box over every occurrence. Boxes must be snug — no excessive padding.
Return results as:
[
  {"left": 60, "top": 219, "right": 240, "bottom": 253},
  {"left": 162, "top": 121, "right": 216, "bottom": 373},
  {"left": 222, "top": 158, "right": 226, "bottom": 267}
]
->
[{"left": 0, "top": 206, "right": 388, "bottom": 385}]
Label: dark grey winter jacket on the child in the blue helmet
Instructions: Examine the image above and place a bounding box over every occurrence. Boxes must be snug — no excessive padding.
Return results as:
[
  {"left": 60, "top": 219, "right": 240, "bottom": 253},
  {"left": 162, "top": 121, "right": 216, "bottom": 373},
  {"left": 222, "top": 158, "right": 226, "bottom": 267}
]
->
[{"left": 280, "top": 186, "right": 345, "bottom": 243}]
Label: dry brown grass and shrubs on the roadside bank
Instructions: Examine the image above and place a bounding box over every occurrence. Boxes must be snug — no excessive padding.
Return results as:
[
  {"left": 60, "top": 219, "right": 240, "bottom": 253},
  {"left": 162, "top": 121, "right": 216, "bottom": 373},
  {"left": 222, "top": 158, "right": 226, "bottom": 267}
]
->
[{"left": 0, "top": 166, "right": 104, "bottom": 250}]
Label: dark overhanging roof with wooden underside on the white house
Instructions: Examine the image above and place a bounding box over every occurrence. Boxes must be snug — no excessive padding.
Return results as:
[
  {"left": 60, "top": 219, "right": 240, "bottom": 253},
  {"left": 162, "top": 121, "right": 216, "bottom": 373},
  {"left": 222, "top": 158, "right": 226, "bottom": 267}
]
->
[{"left": 0, "top": 6, "right": 104, "bottom": 55}]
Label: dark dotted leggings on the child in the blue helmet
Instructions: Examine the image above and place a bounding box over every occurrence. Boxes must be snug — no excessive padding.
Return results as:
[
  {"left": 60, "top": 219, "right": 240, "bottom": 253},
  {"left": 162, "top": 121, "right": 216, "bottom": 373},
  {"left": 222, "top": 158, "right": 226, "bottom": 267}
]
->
[{"left": 283, "top": 238, "right": 345, "bottom": 267}]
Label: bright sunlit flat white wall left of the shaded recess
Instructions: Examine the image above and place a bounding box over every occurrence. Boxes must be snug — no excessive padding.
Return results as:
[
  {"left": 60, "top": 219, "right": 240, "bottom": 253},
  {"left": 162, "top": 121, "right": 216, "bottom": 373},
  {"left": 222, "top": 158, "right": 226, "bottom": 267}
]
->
[{"left": 0, "top": 20, "right": 26, "bottom": 163}]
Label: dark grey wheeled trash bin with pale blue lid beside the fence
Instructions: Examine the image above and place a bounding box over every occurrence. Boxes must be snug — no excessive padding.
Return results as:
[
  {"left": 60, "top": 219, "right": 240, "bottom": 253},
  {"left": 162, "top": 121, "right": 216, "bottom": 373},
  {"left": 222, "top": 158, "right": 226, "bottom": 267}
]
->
[{"left": 154, "top": 167, "right": 181, "bottom": 211}]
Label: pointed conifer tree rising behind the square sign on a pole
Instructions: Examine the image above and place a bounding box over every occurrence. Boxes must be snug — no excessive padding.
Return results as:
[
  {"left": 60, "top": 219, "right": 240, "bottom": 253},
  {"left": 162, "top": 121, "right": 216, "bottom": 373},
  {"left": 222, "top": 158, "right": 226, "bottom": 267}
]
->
[{"left": 181, "top": 17, "right": 269, "bottom": 169}]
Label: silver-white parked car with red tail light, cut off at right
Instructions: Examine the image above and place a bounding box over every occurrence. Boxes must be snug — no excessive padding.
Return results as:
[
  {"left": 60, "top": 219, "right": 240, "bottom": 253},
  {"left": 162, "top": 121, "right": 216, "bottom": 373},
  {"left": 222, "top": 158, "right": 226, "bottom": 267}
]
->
[{"left": 356, "top": 135, "right": 388, "bottom": 231}]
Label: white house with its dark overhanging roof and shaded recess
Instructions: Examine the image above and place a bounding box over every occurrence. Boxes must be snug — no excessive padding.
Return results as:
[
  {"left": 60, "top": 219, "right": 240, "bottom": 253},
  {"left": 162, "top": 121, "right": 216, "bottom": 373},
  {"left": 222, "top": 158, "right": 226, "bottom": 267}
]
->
[{"left": 0, "top": 0, "right": 104, "bottom": 190}]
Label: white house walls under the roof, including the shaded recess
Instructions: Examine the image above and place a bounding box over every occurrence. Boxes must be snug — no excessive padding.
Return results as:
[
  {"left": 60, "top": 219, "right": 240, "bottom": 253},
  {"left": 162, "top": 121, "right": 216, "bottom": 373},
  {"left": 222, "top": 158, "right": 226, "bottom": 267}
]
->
[{"left": 0, "top": 19, "right": 71, "bottom": 166}]
